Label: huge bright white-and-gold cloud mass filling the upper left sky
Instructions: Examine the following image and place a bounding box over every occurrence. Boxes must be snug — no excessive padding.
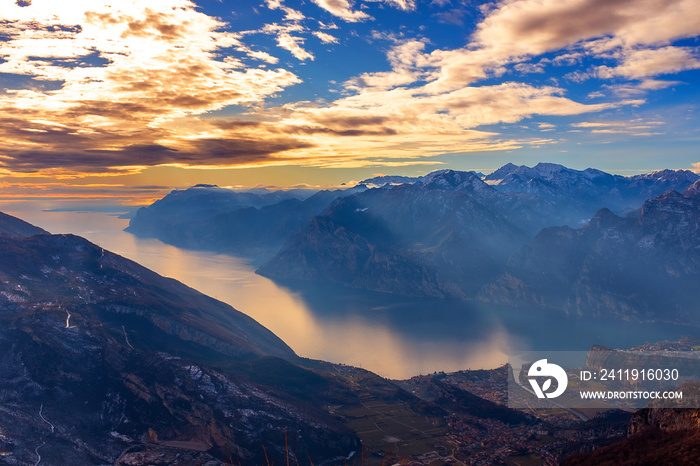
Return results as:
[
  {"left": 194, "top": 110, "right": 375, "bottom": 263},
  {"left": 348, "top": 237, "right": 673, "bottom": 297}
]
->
[{"left": 0, "top": 0, "right": 306, "bottom": 173}]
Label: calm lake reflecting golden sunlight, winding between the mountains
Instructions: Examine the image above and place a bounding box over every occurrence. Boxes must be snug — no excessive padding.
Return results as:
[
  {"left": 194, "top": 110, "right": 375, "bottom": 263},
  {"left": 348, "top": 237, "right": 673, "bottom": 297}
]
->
[{"left": 6, "top": 207, "right": 700, "bottom": 378}]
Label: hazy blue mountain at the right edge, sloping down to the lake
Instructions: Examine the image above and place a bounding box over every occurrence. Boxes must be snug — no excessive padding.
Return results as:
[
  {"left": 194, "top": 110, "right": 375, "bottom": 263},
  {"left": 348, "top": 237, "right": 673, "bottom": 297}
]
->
[{"left": 480, "top": 181, "right": 700, "bottom": 323}]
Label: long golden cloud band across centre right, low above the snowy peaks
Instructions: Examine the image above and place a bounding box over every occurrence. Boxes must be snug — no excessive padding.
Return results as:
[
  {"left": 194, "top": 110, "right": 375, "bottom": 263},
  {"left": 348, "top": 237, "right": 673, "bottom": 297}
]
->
[{"left": 258, "top": 83, "right": 640, "bottom": 166}]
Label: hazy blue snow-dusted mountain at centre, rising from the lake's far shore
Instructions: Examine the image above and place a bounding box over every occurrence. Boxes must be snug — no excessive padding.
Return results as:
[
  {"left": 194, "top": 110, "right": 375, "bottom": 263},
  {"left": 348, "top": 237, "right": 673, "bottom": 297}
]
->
[{"left": 258, "top": 170, "right": 529, "bottom": 297}]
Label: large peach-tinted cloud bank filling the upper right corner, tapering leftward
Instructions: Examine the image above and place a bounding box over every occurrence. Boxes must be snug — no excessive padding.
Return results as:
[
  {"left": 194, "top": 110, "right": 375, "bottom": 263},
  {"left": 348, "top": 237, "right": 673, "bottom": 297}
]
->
[{"left": 416, "top": 0, "right": 700, "bottom": 92}]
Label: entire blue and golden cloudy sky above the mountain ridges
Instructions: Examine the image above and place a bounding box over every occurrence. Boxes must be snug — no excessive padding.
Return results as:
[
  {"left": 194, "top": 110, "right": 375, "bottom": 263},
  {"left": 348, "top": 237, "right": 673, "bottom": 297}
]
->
[{"left": 0, "top": 0, "right": 700, "bottom": 205}]
